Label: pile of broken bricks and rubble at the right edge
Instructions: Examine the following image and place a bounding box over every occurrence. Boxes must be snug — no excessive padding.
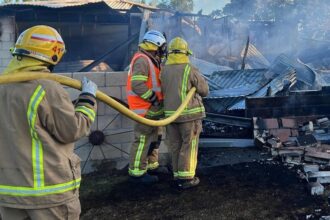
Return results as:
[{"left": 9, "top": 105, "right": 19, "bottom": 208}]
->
[{"left": 253, "top": 117, "right": 330, "bottom": 195}]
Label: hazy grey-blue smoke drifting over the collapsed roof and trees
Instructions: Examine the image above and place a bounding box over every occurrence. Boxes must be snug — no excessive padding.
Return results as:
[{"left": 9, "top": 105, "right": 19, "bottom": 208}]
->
[{"left": 149, "top": 0, "right": 330, "bottom": 69}]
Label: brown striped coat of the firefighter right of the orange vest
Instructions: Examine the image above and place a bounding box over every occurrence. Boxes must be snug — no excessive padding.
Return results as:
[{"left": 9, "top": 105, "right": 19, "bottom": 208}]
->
[{"left": 161, "top": 63, "right": 209, "bottom": 122}]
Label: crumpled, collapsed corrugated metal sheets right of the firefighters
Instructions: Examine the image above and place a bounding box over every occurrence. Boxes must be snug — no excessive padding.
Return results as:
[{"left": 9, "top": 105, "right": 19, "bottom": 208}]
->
[{"left": 205, "top": 55, "right": 318, "bottom": 113}]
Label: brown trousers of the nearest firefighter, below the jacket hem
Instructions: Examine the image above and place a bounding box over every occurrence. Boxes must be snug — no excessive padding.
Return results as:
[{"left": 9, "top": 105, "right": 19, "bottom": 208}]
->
[{"left": 0, "top": 197, "right": 81, "bottom": 220}]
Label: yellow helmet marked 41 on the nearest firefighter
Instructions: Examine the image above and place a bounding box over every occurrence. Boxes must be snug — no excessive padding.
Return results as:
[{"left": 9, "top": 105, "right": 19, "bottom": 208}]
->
[{"left": 12, "top": 25, "right": 65, "bottom": 65}]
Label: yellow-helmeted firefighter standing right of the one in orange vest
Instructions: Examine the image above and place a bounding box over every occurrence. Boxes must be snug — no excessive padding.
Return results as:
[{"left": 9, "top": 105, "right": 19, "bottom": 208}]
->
[{"left": 161, "top": 37, "right": 209, "bottom": 189}]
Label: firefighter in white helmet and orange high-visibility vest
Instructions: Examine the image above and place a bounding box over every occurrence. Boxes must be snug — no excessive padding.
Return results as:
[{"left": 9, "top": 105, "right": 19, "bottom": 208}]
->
[{"left": 126, "top": 30, "right": 166, "bottom": 184}]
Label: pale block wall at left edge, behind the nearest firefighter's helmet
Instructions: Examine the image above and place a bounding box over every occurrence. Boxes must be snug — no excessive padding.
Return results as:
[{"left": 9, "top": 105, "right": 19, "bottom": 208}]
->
[{"left": 0, "top": 17, "right": 15, "bottom": 74}]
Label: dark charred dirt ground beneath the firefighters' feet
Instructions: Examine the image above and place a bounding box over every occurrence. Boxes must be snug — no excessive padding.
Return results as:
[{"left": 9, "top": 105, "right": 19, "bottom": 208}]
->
[{"left": 81, "top": 149, "right": 330, "bottom": 220}]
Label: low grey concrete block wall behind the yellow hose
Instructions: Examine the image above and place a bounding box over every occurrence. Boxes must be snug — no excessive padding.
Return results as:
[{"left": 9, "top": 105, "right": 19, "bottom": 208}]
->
[{"left": 61, "top": 72, "right": 168, "bottom": 173}]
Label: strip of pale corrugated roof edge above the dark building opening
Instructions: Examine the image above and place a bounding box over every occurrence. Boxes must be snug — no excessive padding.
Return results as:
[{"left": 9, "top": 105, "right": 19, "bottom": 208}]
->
[{"left": 0, "top": 0, "right": 157, "bottom": 10}]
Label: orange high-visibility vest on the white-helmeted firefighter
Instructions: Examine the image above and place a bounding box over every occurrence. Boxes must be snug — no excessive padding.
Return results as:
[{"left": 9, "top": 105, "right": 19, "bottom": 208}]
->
[{"left": 126, "top": 52, "right": 163, "bottom": 117}]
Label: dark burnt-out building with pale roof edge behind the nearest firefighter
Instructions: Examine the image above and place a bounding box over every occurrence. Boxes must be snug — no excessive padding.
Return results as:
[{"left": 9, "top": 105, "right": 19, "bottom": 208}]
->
[{"left": 0, "top": 0, "right": 156, "bottom": 72}]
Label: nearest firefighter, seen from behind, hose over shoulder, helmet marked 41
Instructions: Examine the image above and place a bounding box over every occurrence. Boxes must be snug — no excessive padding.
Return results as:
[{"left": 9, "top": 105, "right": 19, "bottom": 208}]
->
[{"left": 0, "top": 25, "right": 97, "bottom": 220}]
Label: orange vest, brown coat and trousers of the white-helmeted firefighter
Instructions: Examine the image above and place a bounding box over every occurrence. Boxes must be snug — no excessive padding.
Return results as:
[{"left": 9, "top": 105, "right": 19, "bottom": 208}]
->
[{"left": 126, "top": 49, "right": 163, "bottom": 177}]
